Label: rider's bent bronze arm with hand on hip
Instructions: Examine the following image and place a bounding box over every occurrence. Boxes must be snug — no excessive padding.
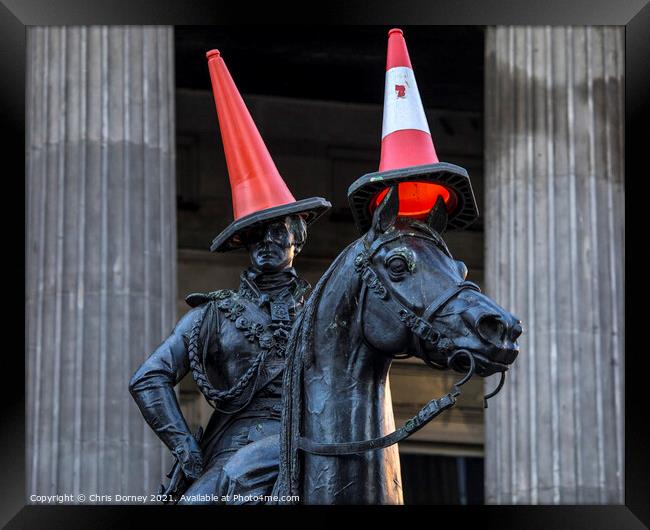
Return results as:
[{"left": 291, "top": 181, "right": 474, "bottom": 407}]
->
[{"left": 129, "top": 308, "right": 203, "bottom": 478}]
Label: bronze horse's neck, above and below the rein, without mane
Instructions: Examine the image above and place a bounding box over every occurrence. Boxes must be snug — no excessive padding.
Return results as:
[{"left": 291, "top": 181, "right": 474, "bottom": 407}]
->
[{"left": 292, "top": 242, "right": 402, "bottom": 504}]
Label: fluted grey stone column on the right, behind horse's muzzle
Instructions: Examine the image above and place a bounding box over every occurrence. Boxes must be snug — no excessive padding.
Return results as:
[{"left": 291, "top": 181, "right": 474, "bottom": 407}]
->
[{"left": 485, "top": 27, "right": 625, "bottom": 504}]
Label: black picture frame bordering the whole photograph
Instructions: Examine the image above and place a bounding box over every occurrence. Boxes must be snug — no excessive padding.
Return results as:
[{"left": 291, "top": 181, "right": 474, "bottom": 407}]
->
[{"left": 0, "top": 0, "right": 650, "bottom": 529}]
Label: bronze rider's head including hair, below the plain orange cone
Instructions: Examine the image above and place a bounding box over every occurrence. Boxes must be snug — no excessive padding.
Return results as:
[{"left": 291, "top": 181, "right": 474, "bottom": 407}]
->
[{"left": 246, "top": 215, "right": 307, "bottom": 272}]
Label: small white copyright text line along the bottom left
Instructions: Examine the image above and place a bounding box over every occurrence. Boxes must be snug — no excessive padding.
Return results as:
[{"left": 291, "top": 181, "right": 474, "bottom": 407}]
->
[{"left": 29, "top": 493, "right": 300, "bottom": 504}]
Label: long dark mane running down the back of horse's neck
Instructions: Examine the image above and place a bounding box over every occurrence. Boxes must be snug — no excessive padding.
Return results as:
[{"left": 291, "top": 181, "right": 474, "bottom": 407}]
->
[{"left": 275, "top": 240, "right": 358, "bottom": 502}]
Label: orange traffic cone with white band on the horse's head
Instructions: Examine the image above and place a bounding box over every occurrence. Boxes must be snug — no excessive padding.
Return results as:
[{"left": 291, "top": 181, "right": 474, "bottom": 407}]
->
[{"left": 348, "top": 29, "right": 478, "bottom": 232}]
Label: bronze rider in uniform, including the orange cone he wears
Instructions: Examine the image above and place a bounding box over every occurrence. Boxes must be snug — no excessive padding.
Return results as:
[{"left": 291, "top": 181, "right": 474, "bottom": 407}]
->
[{"left": 129, "top": 50, "right": 330, "bottom": 504}]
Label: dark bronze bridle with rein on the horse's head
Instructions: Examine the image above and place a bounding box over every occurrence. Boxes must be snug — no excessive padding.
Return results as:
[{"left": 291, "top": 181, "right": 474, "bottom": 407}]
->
[{"left": 298, "top": 227, "right": 505, "bottom": 455}]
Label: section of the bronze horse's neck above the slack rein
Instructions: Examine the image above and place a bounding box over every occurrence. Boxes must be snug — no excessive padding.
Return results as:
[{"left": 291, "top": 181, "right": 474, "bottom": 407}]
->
[{"left": 304, "top": 239, "right": 392, "bottom": 441}]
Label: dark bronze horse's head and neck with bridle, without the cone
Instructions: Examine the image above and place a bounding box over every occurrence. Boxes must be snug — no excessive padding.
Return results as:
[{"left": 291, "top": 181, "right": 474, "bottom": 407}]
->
[{"left": 274, "top": 186, "right": 522, "bottom": 504}]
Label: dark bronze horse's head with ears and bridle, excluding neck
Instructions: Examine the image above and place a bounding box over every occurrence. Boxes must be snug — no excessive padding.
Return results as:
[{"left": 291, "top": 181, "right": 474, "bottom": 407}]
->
[{"left": 355, "top": 187, "right": 522, "bottom": 376}]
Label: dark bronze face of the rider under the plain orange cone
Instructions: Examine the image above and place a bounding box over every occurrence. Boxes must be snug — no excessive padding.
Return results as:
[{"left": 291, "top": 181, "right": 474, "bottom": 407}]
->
[{"left": 246, "top": 220, "right": 296, "bottom": 272}]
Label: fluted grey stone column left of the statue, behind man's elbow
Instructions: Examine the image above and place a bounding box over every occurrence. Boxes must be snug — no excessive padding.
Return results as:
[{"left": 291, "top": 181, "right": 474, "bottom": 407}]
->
[{"left": 26, "top": 26, "right": 176, "bottom": 496}]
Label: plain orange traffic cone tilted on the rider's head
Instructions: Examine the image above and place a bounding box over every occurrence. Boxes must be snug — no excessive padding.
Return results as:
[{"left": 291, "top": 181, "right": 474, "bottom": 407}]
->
[{"left": 206, "top": 50, "right": 331, "bottom": 252}]
